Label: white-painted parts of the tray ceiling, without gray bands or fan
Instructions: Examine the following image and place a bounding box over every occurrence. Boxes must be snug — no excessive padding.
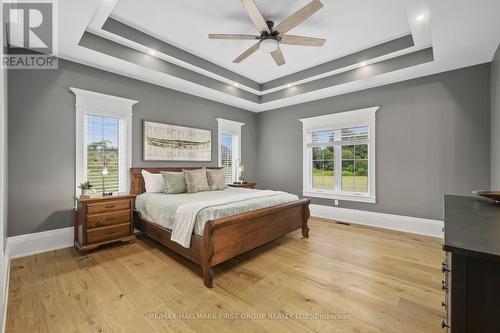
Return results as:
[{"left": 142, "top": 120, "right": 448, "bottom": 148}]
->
[{"left": 57, "top": 0, "right": 500, "bottom": 112}]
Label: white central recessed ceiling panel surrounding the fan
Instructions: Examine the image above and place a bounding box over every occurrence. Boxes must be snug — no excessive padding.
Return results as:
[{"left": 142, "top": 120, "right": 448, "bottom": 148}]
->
[{"left": 112, "top": 0, "right": 410, "bottom": 83}]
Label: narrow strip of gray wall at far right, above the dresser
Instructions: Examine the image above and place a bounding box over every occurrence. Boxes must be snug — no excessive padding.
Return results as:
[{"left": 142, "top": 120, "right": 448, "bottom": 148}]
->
[{"left": 491, "top": 45, "right": 500, "bottom": 190}]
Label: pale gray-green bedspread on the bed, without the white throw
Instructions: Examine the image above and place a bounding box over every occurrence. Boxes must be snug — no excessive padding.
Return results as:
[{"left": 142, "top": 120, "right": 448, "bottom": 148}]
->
[{"left": 135, "top": 187, "right": 299, "bottom": 236}]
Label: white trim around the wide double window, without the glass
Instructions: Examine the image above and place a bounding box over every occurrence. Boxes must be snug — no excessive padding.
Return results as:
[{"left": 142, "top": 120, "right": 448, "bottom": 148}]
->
[{"left": 299, "top": 106, "right": 380, "bottom": 203}]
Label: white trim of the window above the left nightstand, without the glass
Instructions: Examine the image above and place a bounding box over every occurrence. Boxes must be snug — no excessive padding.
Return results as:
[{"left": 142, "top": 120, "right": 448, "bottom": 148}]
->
[{"left": 69, "top": 87, "right": 138, "bottom": 196}]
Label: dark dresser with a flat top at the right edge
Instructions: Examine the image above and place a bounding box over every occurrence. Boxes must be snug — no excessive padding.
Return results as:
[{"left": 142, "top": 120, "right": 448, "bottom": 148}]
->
[{"left": 442, "top": 195, "right": 500, "bottom": 333}]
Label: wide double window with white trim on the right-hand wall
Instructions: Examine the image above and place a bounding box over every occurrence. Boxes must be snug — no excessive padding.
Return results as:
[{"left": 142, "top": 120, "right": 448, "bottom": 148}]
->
[{"left": 300, "top": 107, "right": 378, "bottom": 203}]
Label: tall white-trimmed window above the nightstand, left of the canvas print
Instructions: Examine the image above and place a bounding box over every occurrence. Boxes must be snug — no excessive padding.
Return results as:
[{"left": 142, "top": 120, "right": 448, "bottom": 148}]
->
[{"left": 71, "top": 88, "right": 137, "bottom": 195}]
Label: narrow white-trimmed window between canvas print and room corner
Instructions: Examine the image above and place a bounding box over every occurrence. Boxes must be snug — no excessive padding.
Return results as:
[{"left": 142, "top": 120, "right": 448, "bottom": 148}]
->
[{"left": 217, "top": 118, "right": 245, "bottom": 184}]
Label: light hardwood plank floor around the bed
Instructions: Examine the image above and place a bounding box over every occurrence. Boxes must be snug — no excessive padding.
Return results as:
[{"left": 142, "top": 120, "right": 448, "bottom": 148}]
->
[{"left": 2, "top": 219, "right": 443, "bottom": 333}]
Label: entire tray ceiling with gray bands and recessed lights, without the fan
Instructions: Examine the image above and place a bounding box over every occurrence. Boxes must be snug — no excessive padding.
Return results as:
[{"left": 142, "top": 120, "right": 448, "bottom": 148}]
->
[{"left": 58, "top": 0, "right": 500, "bottom": 112}]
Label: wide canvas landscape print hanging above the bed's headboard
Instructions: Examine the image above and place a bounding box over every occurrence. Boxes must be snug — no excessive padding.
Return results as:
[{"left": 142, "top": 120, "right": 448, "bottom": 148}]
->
[{"left": 144, "top": 121, "right": 212, "bottom": 162}]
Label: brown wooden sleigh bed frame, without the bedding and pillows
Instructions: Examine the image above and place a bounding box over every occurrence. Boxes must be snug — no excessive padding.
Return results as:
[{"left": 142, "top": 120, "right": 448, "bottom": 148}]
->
[{"left": 130, "top": 168, "right": 310, "bottom": 288}]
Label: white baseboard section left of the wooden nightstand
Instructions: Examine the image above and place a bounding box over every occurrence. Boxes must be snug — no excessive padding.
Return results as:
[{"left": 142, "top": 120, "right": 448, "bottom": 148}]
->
[{"left": 7, "top": 227, "right": 74, "bottom": 259}]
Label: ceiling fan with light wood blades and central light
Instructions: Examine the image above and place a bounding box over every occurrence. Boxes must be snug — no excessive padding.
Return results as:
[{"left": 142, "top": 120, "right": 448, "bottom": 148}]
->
[{"left": 208, "top": 0, "right": 326, "bottom": 66}]
